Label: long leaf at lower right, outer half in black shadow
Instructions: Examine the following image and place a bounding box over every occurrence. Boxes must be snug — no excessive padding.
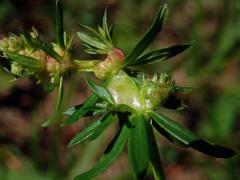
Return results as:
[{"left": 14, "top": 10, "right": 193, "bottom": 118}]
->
[{"left": 148, "top": 111, "right": 235, "bottom": 158}]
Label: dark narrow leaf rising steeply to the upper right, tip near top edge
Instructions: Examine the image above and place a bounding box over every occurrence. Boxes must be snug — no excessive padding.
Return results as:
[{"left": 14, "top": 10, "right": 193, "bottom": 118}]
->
[{"left": 122, "top": 4, "right": 168, "bottom": 67}]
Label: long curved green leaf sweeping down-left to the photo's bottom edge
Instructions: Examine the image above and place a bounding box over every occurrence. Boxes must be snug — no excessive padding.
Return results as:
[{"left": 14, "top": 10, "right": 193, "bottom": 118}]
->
[{"left": 74, "top": 126, "right": 129, "bottom": 180}]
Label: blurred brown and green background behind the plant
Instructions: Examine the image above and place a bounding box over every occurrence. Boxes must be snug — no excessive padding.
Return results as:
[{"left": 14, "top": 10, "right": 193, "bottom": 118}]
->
[{"left": 0, "top": 0, "right": 240, "bottom": 180}]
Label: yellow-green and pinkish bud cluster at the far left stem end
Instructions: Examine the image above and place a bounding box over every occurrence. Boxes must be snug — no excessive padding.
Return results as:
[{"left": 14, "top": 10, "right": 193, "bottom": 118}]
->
[{"left": 0, "top": 29, "right": 73, "bottom": 90}]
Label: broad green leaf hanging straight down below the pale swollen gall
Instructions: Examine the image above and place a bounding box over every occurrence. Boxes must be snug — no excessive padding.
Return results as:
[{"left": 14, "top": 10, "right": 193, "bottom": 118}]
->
[{"left": 128, "top": 115, "right": 149, "bottom": 178}]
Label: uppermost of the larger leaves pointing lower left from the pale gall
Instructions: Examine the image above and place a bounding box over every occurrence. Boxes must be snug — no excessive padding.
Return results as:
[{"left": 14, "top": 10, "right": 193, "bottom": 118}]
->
[{"left": 63, "top": 94, "right": 98, "bottom": 125}]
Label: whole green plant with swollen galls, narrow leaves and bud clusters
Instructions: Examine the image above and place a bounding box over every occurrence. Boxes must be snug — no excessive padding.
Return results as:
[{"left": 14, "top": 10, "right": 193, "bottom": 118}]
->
[{"left": 0, "top": 1, "right": 235, "bottom": 179}]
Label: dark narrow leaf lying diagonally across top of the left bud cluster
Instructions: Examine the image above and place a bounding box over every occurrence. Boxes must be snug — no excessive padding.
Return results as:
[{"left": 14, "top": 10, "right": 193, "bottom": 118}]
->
[{"left": 23, "top": 30, "right": 62, "bottom": 62}]
